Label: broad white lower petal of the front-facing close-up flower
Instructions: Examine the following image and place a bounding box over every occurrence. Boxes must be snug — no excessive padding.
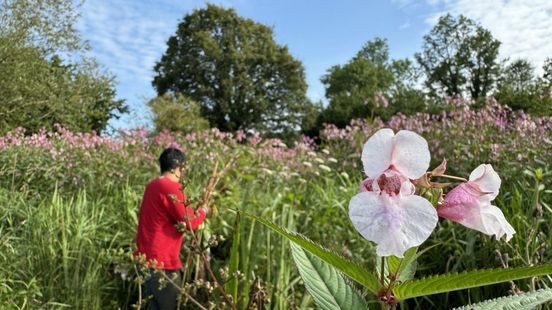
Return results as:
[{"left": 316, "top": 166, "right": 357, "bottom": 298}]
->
[{"left": 349, "top": 192, "right": 437, "bottom": 257}]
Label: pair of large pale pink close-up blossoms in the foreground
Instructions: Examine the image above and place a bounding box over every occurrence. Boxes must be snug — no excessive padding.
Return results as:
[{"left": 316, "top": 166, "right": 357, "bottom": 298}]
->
[{"left": 349, "top": 128, "right": 515, "bottom": 257}]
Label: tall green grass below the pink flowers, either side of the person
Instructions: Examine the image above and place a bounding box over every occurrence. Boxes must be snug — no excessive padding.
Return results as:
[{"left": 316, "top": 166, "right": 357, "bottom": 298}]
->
[{"left": 0, "top": 171, "right": 552, "bottom": 309}]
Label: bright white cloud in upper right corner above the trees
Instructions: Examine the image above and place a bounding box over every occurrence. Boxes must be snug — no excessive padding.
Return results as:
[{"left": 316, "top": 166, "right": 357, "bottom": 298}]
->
[{"left": 426, "top": 0, "right": 552, "bottom": 72}]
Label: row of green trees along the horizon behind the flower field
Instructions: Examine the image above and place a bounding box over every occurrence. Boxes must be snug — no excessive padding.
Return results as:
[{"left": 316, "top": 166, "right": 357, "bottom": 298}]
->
[{"left": 0, "top": 0, "right": 552, "bottom": 137}]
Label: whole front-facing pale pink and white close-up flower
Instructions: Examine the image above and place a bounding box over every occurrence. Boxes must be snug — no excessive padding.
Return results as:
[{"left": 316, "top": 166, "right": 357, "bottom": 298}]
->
[{"left": 349, "top": 129, "right": 438, "bottom": 257}]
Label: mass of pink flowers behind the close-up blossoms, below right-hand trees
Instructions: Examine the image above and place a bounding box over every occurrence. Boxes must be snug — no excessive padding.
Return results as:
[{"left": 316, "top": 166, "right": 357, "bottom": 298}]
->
[{"left": 321, "top": 99, "right": 552, "bottom": 182}]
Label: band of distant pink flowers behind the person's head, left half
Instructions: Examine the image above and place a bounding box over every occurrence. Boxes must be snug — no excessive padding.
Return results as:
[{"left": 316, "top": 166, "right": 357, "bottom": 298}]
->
[{"left": 0, "top": 125, "right": 324, "bottom": 194}]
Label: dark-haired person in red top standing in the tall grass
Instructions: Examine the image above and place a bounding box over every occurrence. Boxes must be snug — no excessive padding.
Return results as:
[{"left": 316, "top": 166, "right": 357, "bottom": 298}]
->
[{"left": 135, "top": 148, "right": 208, "bottom": 310}]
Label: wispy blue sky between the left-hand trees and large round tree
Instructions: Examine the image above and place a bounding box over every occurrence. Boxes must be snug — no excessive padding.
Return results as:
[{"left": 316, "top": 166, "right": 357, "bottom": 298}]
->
[{"left": 77, "top": 0, "right": 212, "bottom": 128}]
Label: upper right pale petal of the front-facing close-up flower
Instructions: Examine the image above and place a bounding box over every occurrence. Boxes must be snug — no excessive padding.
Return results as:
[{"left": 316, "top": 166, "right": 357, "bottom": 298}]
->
[{"left": 391, "top": 130, "right": 431, "bottom": 179}]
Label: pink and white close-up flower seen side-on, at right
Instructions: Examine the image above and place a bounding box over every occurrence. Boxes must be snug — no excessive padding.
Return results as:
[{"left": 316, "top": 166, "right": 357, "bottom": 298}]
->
[{"left": 437, "top": 164, "right": 515, "bottom": 241}]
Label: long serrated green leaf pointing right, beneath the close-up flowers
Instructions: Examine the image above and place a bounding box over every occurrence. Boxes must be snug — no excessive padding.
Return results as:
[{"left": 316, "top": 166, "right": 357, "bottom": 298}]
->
[{"left": 393, "top": 264, "right": 552, "bottom": 300}]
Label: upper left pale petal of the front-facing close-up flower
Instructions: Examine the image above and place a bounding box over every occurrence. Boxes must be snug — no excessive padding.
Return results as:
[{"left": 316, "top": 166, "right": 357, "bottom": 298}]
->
[{"left": 361, "top": 128, "right": 395, "bottom": 179}]
